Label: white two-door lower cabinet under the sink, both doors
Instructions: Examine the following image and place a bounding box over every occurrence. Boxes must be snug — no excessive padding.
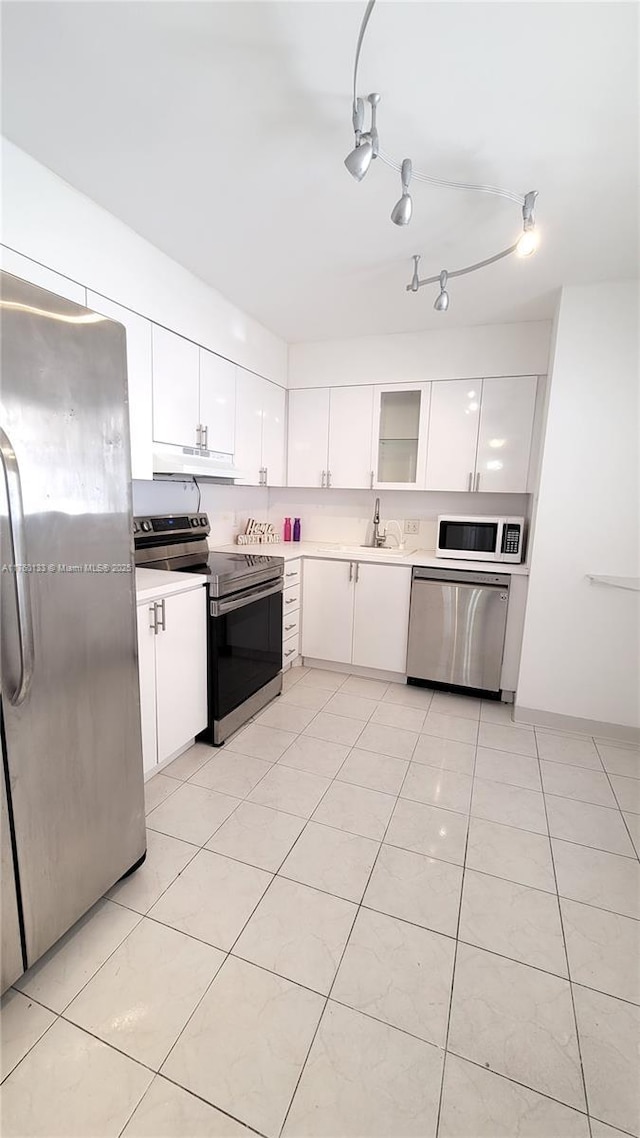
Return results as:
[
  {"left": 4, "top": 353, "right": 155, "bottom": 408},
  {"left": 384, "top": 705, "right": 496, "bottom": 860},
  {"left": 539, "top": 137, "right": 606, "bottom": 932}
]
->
[{"left": 302, "top": 560, "right": 411, "bottom": 673}]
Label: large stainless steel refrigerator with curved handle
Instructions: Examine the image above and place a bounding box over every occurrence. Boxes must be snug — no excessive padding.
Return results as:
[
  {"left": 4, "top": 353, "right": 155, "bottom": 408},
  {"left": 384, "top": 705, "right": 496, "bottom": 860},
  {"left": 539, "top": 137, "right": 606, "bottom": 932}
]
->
[{"left": 0, "top": 273, "right": 146, "bottom": 991}]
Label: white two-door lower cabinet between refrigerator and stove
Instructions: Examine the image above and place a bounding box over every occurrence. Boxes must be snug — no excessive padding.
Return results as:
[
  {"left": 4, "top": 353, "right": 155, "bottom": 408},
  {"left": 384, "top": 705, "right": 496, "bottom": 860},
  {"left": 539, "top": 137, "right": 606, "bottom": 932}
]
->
[{"left": 138, "top": 587, "right": 207, "bottom": 773}]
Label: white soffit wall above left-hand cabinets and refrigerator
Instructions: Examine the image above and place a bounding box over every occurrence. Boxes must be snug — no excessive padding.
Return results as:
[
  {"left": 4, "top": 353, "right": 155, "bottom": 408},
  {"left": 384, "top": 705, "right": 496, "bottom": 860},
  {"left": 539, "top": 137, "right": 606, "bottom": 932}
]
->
[{"left": 2, "top": 139, "right": 287, "bottom": 387}]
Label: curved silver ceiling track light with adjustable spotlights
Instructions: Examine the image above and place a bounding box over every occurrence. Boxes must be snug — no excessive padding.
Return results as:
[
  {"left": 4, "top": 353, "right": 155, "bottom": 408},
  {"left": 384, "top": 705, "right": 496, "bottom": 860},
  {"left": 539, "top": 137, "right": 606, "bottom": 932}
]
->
[{"left": 345, "top": 0, "right": 539, "bottom": 312}]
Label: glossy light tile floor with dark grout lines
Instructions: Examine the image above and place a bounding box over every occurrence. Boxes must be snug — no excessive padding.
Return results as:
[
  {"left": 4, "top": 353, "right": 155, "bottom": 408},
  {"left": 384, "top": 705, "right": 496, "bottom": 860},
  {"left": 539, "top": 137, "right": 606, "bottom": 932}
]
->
[{"left": 1, "top": 668, "right": 640, "bottom": 1138}]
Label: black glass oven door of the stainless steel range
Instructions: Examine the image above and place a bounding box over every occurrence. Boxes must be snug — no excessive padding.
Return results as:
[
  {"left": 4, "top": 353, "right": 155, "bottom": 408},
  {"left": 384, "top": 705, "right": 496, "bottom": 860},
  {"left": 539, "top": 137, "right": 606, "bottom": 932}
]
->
[{"left": 208, "top": 579, "right": 282, "bottom": 727}]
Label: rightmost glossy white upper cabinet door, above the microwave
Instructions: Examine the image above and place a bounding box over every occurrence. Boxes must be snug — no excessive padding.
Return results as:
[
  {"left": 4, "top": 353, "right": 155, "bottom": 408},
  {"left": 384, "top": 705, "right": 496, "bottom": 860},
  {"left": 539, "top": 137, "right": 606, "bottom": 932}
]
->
[{"left": 475, "top": 376, "right": 538, "bottom": 494}]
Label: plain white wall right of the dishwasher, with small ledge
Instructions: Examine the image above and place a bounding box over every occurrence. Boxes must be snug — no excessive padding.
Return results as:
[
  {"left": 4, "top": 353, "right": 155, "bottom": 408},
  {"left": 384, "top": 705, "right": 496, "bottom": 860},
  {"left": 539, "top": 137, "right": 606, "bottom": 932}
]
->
[{"left": 516, "top": 282, "right": 640, "bottom": 736}]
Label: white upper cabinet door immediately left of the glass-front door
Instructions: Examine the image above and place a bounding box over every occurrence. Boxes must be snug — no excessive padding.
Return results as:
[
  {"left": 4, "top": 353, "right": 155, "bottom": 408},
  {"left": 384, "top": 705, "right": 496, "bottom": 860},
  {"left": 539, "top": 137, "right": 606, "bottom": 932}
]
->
[{"left": 327, "top": 387, "right": 374, "bottom": 489}]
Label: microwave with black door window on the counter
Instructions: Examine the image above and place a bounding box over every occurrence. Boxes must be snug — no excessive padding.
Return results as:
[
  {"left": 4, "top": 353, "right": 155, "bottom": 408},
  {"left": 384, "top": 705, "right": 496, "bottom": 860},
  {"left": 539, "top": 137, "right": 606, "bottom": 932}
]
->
[{"left": 436, "top": 516, "right": 525, "bottom": 562}]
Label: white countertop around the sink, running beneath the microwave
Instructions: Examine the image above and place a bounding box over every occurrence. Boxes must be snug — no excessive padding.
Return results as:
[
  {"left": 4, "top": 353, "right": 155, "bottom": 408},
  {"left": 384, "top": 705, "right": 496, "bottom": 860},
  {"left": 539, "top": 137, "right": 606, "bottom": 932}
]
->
[{"left": 209, "top": 542, "right": 528, "bottom": 577}]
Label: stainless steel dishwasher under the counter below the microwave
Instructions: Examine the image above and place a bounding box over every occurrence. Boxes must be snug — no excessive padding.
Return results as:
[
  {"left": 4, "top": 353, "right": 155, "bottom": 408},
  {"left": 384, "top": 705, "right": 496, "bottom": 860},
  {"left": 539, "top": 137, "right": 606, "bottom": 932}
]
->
[{"left": 407, "top": 567, "right": 510, "bottom": 692}]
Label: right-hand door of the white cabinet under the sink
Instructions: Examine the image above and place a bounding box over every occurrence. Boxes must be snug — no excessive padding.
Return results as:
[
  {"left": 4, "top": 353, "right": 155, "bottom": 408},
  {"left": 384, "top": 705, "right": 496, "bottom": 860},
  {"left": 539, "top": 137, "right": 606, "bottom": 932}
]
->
[{"left": 350, "top": 562, "right": 411, "bottom": 673}]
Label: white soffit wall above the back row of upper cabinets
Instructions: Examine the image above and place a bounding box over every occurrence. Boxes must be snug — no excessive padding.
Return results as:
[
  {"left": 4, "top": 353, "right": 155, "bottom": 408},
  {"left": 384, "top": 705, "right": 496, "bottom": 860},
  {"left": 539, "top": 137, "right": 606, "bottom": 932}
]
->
[{"left": 289, "top": 318, "right": 551, "bottom": 387}]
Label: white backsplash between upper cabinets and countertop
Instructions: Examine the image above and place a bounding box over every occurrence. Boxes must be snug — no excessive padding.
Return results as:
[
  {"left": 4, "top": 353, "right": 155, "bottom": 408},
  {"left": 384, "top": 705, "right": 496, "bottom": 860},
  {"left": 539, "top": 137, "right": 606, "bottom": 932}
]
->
[{"left": 133, "top": 479, "right": 532, "bottom": 550}]
